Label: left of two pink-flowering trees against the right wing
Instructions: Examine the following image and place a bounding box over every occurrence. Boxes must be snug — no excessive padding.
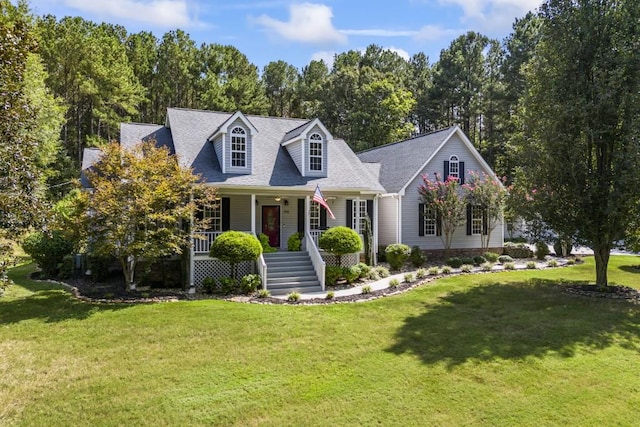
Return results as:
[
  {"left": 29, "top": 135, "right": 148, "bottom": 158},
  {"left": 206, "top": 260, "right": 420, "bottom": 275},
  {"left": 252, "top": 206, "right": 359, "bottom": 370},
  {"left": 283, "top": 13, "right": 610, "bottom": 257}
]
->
[{"left": 418, "top": 175, "right": 466, "bottom": 256}]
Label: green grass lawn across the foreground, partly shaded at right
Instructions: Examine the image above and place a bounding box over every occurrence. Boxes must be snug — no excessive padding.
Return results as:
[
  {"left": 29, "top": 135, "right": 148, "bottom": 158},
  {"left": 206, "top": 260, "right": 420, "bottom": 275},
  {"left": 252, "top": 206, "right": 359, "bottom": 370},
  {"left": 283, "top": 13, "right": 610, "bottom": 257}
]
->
[{"left": 0, "top": 256, "right": 640, "bottom": 426}]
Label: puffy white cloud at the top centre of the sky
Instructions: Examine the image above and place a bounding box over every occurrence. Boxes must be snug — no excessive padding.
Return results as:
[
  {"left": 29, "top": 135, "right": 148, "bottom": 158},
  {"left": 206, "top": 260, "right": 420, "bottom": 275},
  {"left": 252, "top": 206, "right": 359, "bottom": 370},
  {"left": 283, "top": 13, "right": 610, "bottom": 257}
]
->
[{"left": 255, "top": 3, "right": 347, "bottom": 43}]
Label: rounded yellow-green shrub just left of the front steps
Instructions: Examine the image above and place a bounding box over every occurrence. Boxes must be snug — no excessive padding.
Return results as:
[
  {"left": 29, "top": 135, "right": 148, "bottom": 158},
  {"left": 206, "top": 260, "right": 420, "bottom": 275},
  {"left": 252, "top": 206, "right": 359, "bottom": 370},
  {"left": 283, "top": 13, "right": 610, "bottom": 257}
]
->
[{"left": 209, "top": 231, "right": 262, "bottom": 280}]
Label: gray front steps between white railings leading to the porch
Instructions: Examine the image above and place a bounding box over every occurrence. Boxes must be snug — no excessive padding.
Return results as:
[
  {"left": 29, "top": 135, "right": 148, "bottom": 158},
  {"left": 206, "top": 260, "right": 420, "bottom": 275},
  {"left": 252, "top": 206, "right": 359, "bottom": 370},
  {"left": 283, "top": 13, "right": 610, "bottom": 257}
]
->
[{"left": 263, "top": 252, "right": 322, "bottom": 295}]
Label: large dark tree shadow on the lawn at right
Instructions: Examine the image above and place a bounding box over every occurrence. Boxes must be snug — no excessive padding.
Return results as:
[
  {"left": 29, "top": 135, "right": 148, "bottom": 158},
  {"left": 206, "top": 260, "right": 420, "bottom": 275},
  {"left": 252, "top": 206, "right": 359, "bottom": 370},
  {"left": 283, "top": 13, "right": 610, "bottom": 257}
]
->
[{"left": 387, "top": 279, "right": 640, "bottom": 368}]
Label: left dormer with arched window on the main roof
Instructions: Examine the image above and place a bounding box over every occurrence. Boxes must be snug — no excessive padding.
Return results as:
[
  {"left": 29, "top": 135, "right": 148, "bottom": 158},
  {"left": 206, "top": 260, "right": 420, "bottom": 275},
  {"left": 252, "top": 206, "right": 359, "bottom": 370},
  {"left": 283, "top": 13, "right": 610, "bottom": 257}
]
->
[{"left": 208, "top": 111, "right": 258, "bottom": 175}]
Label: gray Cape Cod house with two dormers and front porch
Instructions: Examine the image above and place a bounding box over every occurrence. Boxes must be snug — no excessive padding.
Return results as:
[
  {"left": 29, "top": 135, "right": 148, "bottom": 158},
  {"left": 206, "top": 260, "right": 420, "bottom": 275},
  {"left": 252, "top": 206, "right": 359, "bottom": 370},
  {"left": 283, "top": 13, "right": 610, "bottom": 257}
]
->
[{"left": 83, "top": 108, "right": 502, "bottom": 293}]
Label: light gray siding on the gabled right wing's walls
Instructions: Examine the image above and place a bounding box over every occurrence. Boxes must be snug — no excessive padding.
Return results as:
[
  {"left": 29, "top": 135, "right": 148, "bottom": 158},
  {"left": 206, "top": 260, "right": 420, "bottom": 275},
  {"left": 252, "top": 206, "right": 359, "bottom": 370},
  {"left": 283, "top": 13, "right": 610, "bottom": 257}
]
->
[{"left": 401, "top": 135, "right": 503, "bottom": 249}]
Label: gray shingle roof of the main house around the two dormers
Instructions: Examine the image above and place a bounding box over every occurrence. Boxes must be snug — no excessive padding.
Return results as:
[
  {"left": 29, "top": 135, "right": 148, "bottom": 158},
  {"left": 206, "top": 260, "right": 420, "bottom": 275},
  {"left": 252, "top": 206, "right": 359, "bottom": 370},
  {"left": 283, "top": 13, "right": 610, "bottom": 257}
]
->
[{"left": 121, "top": 108, "right": 384, "bottom": 192}]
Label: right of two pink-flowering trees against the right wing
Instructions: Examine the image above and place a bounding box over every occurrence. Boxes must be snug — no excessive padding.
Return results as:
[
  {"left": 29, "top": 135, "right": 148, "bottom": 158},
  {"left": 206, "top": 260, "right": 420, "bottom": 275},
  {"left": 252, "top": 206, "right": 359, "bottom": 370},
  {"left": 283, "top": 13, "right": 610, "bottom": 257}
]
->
[{"left": 462, "top": 171, "right": 508, "bottom": 249}]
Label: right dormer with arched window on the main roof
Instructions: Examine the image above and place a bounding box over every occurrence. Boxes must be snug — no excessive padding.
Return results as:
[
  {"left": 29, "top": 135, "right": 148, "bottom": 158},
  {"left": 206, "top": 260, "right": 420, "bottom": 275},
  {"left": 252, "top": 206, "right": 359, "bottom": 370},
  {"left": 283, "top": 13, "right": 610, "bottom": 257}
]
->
[{"left": 280, "top": 119, "right": 333, "bottom": 178}]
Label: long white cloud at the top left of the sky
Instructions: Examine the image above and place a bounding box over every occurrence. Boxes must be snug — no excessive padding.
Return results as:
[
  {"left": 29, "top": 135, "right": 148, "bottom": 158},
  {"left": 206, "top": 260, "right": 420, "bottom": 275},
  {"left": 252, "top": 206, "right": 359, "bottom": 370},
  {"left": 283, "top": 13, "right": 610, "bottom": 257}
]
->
[{"left": 64, "top": 0, "right": 197, "bottom": 28}]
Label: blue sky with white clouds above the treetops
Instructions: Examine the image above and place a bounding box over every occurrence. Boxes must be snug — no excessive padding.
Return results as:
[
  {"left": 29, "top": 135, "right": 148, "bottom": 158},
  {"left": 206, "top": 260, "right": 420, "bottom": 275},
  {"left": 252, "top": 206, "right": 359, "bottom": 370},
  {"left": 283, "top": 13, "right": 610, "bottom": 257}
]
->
[{"left": 29, "top": 0, "right": 541, "bottom": 70}]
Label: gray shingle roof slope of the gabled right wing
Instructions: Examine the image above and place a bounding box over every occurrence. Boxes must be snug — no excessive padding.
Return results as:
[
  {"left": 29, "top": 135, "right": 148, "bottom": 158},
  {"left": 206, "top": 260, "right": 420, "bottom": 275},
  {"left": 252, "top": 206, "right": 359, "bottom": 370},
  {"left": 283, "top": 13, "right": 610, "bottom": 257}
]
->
[{"left": 358, "top": 127, "right": 456, "bottom": 193}]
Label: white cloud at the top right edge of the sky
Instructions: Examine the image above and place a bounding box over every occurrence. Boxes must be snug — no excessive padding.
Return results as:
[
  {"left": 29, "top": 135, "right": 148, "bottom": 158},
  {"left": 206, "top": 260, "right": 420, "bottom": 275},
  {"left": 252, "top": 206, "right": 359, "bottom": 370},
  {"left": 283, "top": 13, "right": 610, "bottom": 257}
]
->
[{"left": 440, "top": 0, "right": 542, "bottom": 33}]
